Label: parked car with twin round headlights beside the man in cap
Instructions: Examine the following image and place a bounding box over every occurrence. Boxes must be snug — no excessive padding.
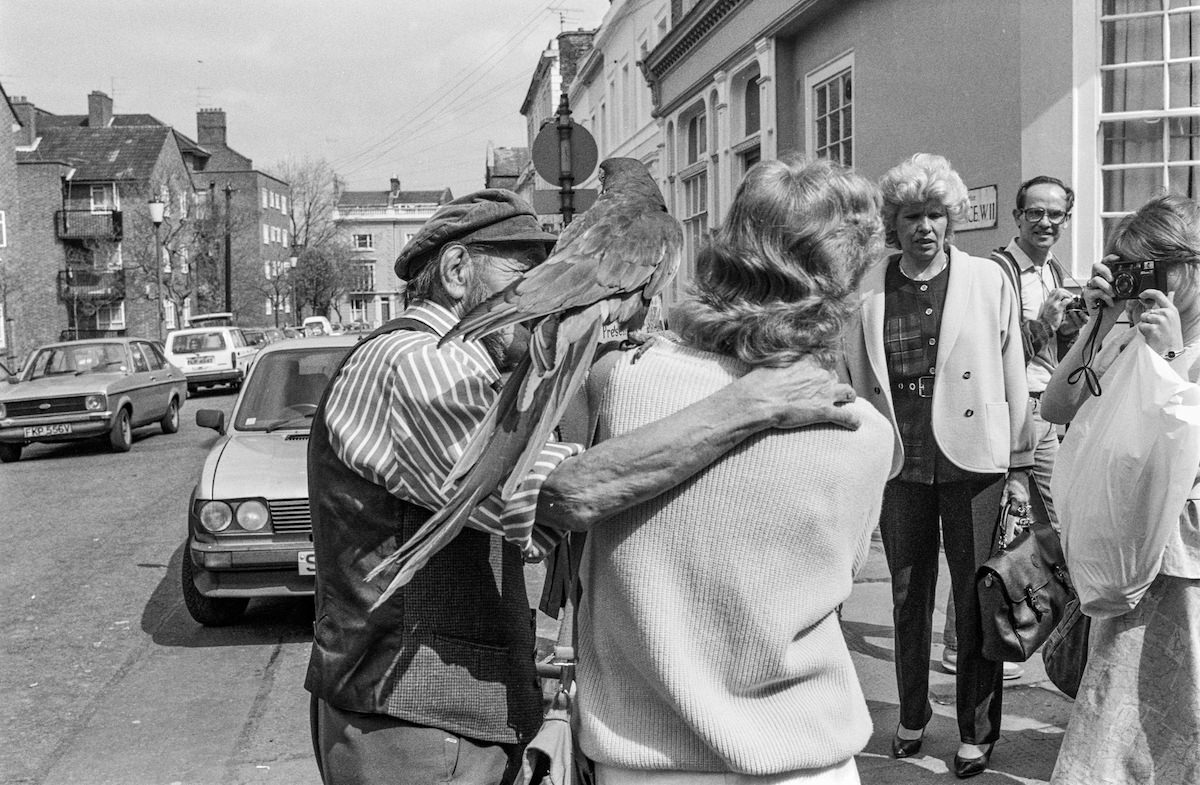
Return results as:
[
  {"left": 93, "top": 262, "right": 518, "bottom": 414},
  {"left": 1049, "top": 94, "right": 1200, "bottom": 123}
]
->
[{"left": 181, "top": 336, "right": 356, "bottom": 625}]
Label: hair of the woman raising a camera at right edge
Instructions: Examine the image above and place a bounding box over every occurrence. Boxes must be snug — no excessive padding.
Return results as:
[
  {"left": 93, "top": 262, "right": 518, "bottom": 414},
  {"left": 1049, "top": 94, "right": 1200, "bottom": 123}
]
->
[{"left": 1106, "top": 194, "right": 1200, "bottom": 294}]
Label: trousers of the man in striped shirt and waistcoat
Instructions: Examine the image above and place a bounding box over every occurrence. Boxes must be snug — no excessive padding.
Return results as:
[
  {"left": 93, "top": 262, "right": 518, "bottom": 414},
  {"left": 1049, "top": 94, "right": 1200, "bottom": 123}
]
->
[{"left": 310, "top": 697, "right": 522, "bottom": 785}]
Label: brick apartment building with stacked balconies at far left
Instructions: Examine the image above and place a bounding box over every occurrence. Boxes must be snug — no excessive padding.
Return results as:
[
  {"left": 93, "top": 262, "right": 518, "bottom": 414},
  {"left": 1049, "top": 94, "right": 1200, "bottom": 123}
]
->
[{"left": 6, "top": 91, "right": 194, "bottom": 358}]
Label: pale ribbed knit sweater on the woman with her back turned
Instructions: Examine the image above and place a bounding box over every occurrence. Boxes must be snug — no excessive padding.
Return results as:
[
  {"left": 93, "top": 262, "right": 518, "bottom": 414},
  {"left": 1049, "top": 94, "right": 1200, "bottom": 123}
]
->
[{"left": 576, "top": 343, "right": 892, "bottom": 775}]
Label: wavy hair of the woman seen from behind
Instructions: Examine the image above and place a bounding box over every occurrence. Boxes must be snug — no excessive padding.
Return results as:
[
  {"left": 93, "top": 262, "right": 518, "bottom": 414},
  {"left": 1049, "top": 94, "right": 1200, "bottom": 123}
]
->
[{"left": 672, "top": 155, "right": 882, "bottom": 366}]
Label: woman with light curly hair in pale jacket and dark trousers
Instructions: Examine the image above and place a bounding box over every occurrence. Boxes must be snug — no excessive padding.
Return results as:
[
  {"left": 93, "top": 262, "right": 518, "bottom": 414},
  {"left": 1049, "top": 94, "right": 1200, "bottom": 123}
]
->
[{"left": 846, "top": 154, "right": 1032, "bottom": 778}]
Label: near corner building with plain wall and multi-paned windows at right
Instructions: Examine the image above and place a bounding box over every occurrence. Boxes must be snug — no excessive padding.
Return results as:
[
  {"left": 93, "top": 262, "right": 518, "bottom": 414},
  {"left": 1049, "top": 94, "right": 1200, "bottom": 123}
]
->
[{"left": 642, "top": 0, "right": 1200, "bottom": 295}]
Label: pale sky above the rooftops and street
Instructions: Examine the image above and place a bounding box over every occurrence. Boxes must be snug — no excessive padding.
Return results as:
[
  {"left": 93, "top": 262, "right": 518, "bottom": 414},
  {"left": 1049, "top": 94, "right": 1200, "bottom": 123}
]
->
[{"left": 0, "top": 0, "right": 610, "bottom": 196}]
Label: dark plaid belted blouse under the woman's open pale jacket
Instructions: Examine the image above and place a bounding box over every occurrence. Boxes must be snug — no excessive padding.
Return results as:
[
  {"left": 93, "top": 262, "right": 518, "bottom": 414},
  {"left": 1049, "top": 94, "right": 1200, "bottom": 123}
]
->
[{"left": 883, "top": 251, "right": 972, "bottom": 485}]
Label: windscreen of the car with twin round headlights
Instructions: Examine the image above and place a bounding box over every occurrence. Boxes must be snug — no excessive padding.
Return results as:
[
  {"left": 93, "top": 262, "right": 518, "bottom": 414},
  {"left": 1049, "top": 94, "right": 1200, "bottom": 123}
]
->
[{"left": 234, "top": 346, "right": 352, "bottom": 431}]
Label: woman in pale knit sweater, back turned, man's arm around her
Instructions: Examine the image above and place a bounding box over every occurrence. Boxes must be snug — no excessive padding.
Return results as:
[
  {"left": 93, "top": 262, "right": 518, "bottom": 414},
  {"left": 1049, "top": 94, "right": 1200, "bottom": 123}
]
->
[{"left": 576, "top": 158, "right": 890, "bottom": 785}]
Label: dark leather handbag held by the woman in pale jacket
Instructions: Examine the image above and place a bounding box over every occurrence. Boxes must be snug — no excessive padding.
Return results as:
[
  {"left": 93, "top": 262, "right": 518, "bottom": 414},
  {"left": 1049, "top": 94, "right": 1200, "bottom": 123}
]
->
[{"left": 976, "top": 509, "right": 1074, "bottom": 663}]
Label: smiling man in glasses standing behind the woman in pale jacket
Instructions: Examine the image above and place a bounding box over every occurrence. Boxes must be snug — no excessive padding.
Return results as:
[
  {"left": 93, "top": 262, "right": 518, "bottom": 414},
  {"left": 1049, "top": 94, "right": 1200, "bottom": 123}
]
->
[{"left": 942, "top": 174, "right": 1087, "bottom": 679}]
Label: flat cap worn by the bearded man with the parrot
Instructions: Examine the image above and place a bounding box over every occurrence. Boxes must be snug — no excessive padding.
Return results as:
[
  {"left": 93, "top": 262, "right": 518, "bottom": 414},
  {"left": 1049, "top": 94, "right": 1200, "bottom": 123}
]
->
[{"left": 396, "top": 188, "right": 558, "bottom": 281}]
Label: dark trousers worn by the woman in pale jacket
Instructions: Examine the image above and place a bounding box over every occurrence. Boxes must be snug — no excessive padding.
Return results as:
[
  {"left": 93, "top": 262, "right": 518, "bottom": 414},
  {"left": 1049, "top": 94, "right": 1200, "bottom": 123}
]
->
[{"left": 880, "top": 474, "right": 1004, "bottom": 744}]
